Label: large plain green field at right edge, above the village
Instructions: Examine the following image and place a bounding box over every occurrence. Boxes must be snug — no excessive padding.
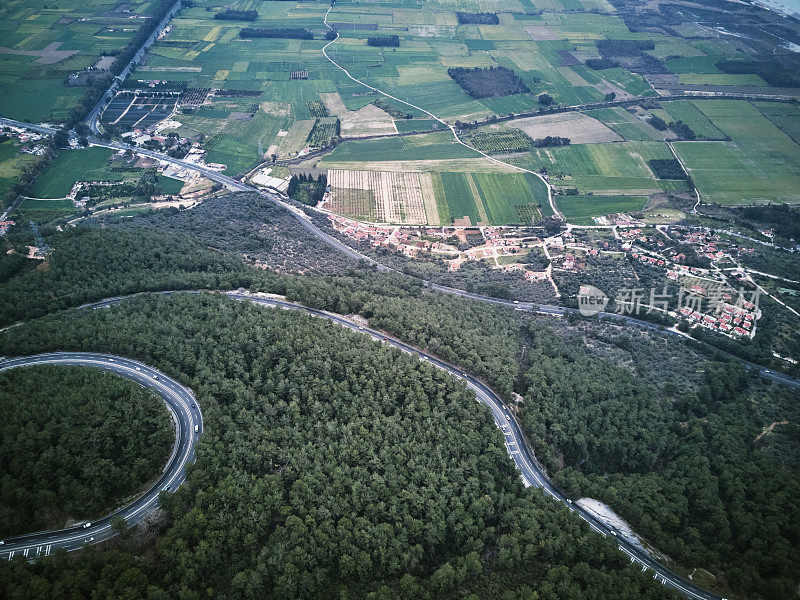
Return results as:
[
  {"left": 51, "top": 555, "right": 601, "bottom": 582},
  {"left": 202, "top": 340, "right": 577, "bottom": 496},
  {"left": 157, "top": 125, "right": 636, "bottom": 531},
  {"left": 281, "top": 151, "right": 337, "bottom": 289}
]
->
[{"left": 674, "top": 100, "right": 800, "bottom": 205}]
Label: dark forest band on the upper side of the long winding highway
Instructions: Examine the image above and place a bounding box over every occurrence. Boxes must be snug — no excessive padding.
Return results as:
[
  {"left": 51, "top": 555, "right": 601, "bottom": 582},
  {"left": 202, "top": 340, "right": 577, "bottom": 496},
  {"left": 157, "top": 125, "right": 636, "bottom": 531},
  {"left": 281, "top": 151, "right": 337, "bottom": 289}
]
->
[{"left": 0, "top": 200, "right": 800, "bottom": 598}]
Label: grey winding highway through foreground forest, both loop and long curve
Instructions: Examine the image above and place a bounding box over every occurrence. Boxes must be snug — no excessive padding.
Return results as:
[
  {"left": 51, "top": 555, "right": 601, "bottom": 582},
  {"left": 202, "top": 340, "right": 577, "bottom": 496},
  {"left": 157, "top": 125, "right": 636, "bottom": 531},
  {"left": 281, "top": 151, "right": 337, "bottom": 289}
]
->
[{"left": 0, "top": 291, "right": 748, "bottom": 600}]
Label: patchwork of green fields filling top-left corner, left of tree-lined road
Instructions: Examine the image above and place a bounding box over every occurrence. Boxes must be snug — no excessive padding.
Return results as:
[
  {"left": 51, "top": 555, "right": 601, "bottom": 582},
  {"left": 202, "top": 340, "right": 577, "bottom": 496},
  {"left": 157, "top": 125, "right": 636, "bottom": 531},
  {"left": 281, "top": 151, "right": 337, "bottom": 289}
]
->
[{"left": 0, "top": 0, "right": 164, "bottom": 122}]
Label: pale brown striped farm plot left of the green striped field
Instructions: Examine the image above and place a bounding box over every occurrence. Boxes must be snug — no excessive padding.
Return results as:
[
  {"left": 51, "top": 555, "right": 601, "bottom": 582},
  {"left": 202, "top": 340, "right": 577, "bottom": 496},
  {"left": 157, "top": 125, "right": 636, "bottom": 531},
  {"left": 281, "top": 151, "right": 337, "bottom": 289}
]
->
[{"left": 326, "top": 169, "right": 436, "bottom": 225}]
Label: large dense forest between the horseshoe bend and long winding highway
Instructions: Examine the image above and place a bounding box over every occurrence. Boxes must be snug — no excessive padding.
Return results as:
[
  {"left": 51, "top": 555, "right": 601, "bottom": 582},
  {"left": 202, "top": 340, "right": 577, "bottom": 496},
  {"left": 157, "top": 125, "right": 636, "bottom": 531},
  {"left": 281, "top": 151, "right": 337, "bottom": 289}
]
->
[{"left": 0, "top": 290, "right": 677, "bottom": 600}]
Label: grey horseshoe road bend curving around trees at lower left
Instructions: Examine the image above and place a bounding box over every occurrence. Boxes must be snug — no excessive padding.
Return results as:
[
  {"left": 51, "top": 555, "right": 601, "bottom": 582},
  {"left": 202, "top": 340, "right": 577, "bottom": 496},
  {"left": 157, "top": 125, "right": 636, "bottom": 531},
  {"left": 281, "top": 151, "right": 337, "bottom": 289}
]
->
[{"left": 0, "top": 352, "right": 203, "bottom": 560}]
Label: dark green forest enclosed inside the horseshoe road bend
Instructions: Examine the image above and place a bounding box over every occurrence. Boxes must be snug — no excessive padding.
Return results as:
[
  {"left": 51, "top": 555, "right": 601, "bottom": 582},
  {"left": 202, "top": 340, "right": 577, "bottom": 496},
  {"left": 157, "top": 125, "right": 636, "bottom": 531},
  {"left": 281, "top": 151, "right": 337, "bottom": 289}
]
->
[{"left": 0, "top": 365, "right": 172, "bottom": 537}]
